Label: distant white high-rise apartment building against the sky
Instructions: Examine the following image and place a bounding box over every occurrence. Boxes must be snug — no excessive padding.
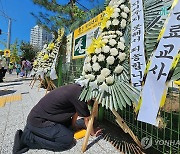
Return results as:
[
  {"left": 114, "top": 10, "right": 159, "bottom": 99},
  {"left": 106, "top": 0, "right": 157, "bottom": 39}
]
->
[{"left": 30, "top": 25, "right": 53, "bottom": 50}]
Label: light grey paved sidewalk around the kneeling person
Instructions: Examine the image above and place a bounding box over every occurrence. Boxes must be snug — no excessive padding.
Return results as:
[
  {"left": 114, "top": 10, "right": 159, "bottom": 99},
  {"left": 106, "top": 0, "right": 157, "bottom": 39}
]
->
[{"left": 0, "top": 74, "right": 120, "bottom": 154}]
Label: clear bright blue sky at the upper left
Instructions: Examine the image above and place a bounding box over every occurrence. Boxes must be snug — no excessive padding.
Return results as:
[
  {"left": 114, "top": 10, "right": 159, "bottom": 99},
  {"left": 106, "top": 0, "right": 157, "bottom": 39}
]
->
[{"left": 0, "top": 0, "right": 104, "bottom": 50}]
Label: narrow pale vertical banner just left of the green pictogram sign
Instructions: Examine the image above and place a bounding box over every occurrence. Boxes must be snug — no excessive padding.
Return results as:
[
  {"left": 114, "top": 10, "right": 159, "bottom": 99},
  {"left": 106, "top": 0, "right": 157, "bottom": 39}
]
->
[{"left": 66, "top": 33, "right": 73, "bottom": 63}]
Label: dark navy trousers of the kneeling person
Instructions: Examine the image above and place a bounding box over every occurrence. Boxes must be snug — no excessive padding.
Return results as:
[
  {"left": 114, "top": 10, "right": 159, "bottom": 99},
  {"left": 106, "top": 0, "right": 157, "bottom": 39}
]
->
[{"left": 21, "top": 123, "right": 75, "bottom": 151}]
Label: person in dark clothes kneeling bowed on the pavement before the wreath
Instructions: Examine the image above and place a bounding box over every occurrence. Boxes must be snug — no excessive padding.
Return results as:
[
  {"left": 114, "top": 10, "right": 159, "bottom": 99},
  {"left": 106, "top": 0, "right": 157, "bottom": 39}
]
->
[{"left": 13, "top": 84, "right": 99, "bottom": 154}]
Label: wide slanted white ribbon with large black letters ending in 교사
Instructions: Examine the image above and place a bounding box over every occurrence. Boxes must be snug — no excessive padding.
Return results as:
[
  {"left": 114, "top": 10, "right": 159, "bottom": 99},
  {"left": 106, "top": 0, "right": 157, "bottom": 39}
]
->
[{"left": 138, "top": 1, "right": 180, "bottom": 126}]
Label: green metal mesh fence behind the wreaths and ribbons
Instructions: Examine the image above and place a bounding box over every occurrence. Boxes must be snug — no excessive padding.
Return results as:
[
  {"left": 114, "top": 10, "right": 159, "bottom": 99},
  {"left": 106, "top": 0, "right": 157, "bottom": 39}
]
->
[{"left": 62, "top": 60, "right": 180, "bottom": 154}]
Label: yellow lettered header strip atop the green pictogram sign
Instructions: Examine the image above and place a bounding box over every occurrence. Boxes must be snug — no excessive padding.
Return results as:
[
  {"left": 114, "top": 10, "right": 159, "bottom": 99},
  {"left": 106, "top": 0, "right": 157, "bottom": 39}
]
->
[{"left": 74, "top": 13, "right": 104, "bottom": 38}]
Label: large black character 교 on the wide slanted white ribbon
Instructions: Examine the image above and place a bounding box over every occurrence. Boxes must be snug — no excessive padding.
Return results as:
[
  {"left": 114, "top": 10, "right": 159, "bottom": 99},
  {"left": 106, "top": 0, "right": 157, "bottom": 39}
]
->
[{"left": 155, "top": 44, "right": 174, "bottom": 59}]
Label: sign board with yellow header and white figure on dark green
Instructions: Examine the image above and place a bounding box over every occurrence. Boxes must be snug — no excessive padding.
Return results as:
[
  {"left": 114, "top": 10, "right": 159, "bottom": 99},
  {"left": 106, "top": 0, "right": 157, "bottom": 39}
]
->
[{"left": 73, "top": 13, "right": 103, "bottom": 59}]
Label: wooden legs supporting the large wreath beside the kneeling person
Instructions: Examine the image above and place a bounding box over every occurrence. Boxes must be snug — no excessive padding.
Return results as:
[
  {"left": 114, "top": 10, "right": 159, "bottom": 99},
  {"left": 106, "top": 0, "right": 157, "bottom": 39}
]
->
[{"left": 82, "top": 100, "right": 142, "bottom": 152}]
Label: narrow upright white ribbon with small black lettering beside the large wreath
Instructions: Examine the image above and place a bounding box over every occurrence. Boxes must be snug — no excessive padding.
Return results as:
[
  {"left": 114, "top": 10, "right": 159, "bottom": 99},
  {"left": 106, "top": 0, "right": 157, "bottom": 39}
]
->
[{"left": 130, "top": 0, "right": 146, "bottom": 90}]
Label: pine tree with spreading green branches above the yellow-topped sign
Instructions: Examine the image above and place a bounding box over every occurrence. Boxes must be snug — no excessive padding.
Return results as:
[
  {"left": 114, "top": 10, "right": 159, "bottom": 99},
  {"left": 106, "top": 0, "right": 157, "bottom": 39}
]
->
[{"left": 31, "top": 0, "right": 101, "bottom": 32}]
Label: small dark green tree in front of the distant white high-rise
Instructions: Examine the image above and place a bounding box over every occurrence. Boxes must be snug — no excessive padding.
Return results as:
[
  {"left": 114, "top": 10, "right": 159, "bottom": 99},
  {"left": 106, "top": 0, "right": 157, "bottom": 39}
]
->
[{"left": 20, "top": 41, "right": 38, "bottom": 61}]
